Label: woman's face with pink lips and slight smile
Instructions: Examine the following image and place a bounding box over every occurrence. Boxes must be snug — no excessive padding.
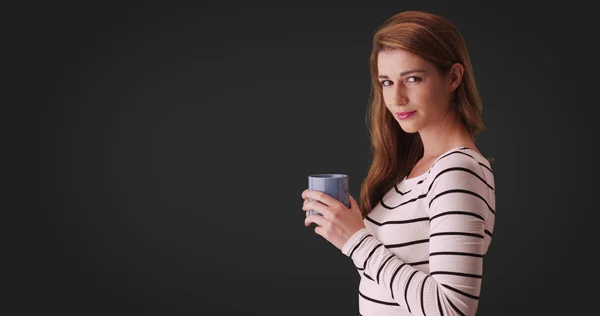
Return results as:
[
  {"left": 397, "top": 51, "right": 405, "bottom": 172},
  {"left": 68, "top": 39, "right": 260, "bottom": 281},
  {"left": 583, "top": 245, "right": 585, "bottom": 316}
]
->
[{"left": 377, "top": 49, "right": 457, "bottom": 133}]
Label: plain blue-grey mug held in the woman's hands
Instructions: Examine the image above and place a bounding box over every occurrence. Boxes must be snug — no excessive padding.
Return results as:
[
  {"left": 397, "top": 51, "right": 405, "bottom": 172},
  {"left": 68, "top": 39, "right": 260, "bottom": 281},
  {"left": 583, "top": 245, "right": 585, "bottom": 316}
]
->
[{"left": 308, "top": 173, "right": 350, "bottom": 215}]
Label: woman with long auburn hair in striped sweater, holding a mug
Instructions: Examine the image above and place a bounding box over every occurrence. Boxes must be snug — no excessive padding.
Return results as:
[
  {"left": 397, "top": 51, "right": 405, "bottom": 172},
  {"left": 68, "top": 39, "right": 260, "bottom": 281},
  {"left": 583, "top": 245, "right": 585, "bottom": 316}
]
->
[{"left": 302, "top": 11, "right": 496, "bottom": 316}]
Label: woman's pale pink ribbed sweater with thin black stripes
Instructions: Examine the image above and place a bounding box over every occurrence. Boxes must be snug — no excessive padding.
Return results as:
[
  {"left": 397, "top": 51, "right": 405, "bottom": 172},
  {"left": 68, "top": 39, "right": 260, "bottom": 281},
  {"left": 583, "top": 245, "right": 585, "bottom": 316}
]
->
[{"left": 342, "top": 147, "right": 496, "bottom": 316}]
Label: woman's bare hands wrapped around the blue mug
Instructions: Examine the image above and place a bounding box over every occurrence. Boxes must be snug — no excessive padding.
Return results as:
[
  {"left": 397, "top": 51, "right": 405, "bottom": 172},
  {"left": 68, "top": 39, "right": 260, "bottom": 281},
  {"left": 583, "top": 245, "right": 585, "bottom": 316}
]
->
[{"left": 302, "top": 190, "right": 365, "bottom": 250}]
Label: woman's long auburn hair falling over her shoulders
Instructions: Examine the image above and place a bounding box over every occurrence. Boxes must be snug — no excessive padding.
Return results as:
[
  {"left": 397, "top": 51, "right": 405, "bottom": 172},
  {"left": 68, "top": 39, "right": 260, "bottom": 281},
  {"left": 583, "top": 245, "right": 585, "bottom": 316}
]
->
[{"left": 359, "top": 11, "right": 491, "bottom": 217}]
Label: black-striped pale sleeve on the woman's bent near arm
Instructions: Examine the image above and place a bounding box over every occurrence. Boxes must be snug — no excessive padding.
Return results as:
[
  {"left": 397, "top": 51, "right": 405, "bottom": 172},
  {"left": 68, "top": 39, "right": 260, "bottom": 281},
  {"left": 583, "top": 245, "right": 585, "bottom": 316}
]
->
[{"left": 342, "top": 159, "right": 495, "bottom": 316}]
